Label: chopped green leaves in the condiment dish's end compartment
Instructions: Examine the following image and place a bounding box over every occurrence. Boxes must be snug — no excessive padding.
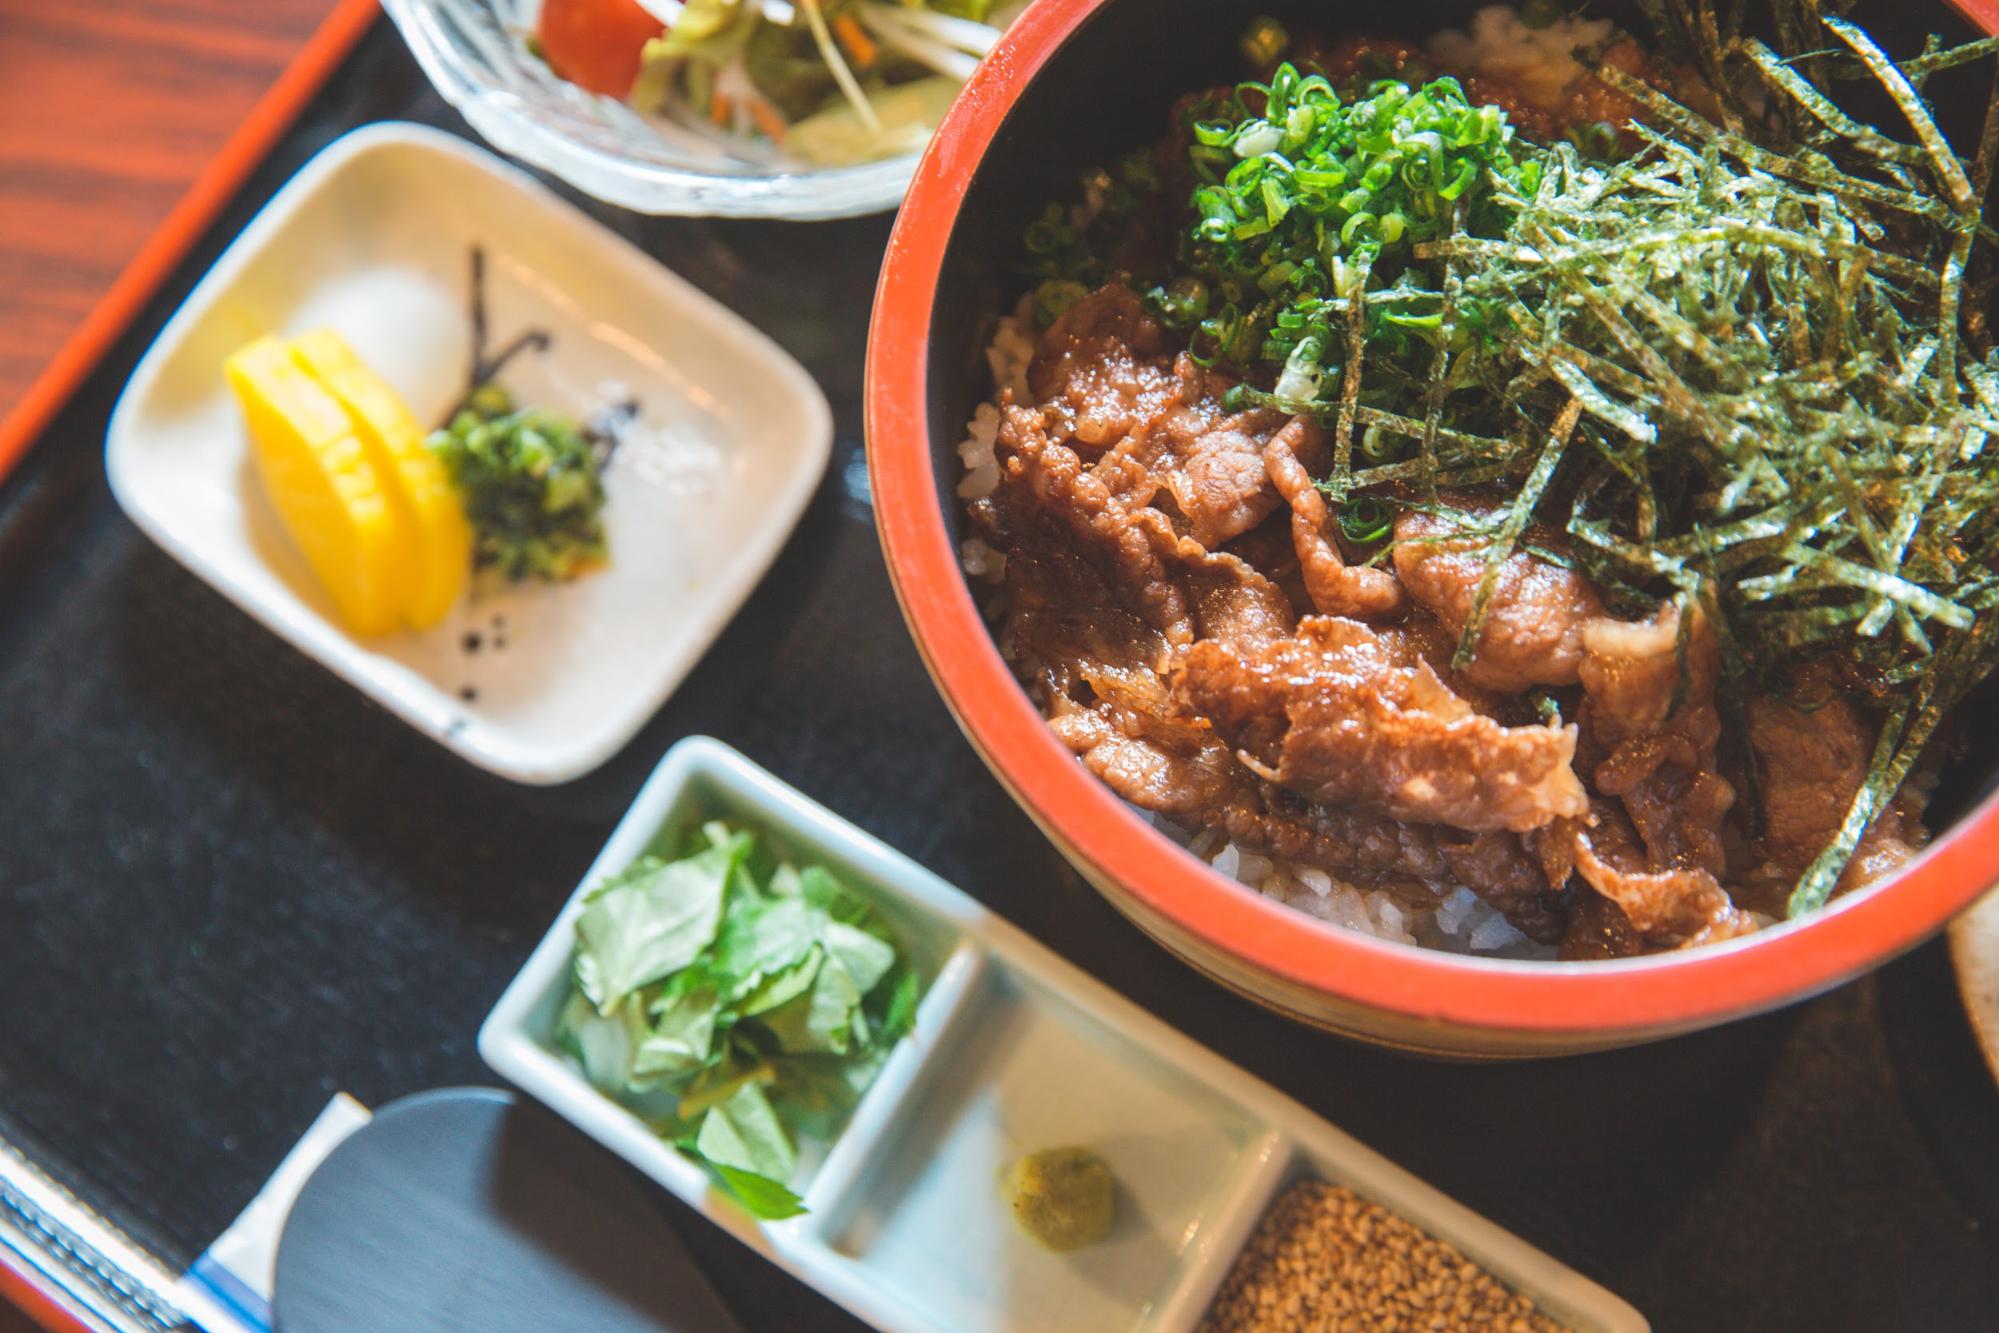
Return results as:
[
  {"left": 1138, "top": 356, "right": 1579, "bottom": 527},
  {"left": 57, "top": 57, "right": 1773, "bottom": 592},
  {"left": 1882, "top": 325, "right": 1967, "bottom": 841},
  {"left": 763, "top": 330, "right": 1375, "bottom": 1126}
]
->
[{"left": 558, "top": 823, "right": 920, "bottom": 1219}]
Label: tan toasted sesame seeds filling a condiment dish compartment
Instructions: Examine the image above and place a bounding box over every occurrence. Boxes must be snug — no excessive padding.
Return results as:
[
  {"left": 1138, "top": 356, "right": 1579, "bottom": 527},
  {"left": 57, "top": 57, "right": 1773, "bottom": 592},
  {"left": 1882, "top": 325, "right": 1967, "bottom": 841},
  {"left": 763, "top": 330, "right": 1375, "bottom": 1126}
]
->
[{"left": 1201, "top": 1181, "right": 1563, "bottom": 1333}]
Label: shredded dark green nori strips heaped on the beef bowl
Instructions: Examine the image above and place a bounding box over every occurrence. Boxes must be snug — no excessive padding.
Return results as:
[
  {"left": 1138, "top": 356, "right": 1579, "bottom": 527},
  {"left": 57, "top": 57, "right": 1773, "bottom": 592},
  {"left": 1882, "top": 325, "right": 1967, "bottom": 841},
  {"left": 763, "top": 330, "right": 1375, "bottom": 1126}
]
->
[{"left": 1199, "top": 4, "right": 1999, "bottom": 915}]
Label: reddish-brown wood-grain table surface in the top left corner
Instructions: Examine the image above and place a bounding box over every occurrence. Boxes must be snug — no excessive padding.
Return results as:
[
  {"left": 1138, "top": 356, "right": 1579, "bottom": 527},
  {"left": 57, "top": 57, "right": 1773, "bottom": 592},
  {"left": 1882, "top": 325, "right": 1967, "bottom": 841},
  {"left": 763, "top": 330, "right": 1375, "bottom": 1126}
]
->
[{"left": 0, "top": 0, "right": 334, "bottom": 414}]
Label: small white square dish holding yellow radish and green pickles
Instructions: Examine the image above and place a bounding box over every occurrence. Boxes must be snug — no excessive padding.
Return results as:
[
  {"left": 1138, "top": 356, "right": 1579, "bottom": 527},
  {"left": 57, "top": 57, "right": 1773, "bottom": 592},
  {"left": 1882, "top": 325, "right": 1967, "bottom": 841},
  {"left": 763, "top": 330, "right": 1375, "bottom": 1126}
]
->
[{"left": 106, "top": 124, "right": 834, "bottom": 783}]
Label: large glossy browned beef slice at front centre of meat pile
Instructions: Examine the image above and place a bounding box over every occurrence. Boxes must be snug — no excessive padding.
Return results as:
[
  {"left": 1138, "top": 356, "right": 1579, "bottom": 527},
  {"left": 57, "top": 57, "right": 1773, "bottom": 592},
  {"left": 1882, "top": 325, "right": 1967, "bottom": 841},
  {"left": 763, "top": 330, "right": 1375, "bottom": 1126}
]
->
[{"left": 1173, "top": 616, "right": 1587, "bottom": 831}]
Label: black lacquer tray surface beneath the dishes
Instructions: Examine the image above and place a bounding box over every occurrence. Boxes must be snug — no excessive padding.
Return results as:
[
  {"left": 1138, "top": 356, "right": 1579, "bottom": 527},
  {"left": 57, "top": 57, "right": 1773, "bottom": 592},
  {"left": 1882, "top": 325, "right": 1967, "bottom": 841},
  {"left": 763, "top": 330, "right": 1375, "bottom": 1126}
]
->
[{"left": 0, "top": 13, "right": 1999, "bottom": 1329}]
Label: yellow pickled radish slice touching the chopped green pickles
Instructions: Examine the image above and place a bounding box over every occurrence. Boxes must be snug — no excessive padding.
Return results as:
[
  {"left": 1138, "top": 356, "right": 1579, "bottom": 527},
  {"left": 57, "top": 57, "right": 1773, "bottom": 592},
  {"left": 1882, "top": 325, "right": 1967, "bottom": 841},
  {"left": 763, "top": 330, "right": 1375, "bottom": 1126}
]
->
[{"left": 292, "top": 330, "right": 472, "bottom": 630}]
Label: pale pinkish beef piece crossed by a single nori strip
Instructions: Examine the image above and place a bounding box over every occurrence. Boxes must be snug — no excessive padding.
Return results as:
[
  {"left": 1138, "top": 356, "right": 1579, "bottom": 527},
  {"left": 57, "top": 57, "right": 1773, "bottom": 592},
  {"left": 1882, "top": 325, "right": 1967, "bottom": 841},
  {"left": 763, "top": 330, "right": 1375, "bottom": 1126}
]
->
[{"left": 1395, "top": 506, "right": 1603, "bottom": 691}]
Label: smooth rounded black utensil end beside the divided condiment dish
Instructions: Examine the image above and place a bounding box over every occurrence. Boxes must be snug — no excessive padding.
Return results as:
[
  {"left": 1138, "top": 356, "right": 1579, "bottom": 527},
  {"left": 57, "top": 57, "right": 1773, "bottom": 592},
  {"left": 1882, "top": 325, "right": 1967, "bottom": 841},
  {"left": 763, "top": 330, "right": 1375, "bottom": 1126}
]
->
[{"left": 272, "top": 1087, "right": 742, "bottom": 1333}]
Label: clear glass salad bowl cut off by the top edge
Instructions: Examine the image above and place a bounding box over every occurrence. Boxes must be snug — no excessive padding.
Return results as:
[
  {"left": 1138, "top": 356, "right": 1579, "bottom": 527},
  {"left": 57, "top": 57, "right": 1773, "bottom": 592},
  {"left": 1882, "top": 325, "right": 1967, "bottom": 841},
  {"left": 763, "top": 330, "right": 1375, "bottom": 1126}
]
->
[{"left": 382, "top": 0, "right": 972, "bottom": 222}]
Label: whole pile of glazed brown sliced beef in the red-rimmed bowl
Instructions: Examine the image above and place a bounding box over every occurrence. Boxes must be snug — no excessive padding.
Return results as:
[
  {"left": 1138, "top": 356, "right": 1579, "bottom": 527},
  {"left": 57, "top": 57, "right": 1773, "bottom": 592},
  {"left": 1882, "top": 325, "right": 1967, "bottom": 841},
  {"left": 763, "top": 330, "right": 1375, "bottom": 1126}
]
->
[{"left": 970, "top": 252, "right": 1925, "bottom": 957}]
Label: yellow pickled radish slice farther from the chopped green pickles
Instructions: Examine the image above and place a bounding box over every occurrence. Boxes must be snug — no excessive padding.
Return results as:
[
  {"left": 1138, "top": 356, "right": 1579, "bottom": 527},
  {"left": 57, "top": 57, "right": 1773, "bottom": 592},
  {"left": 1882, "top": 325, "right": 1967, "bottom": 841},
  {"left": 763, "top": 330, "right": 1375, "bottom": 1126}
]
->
[{"left": 226, "top": 338, "right": 408, "bottom": 634}]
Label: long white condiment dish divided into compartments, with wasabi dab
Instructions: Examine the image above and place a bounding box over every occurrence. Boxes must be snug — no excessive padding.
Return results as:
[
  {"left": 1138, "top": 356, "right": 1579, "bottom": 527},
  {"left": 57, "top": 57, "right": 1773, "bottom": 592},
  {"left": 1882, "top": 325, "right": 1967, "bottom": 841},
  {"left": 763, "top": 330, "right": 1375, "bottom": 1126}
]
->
[{"left": 480, "top": 737, "right": 1647, "bottom": 1333}]
